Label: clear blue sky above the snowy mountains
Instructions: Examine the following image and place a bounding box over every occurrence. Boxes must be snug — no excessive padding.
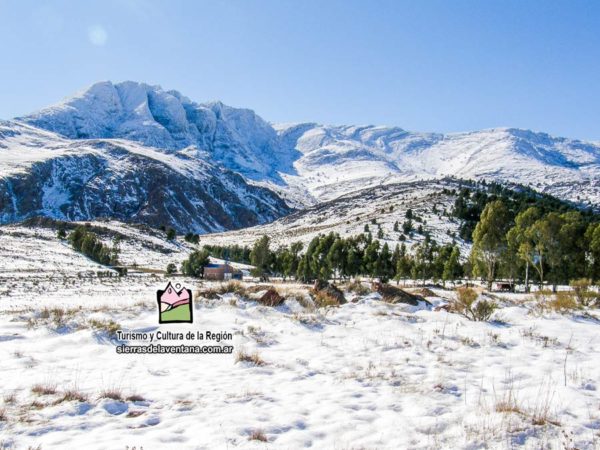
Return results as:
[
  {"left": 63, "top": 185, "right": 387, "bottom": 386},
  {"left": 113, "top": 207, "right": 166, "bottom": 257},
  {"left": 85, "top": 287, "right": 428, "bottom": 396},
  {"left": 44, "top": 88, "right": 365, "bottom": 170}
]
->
[{"left": 0, "top": 0, "right": 600, "bottom": 140}]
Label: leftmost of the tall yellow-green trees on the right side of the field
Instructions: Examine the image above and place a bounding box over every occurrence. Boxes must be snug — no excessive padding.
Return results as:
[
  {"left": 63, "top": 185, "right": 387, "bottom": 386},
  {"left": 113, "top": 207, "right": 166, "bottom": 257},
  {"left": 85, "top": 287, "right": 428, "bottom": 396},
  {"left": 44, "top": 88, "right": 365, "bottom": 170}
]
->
[{"left": 472, "top": 200, "right": 510, "bottom": 290}]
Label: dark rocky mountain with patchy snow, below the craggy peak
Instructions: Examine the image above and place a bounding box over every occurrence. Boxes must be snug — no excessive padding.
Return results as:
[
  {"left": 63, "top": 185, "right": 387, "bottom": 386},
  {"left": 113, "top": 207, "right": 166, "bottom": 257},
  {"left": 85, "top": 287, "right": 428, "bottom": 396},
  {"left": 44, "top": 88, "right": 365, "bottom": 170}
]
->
[{"left": 0, "top": 122, "right": 290, "bottom": 233}]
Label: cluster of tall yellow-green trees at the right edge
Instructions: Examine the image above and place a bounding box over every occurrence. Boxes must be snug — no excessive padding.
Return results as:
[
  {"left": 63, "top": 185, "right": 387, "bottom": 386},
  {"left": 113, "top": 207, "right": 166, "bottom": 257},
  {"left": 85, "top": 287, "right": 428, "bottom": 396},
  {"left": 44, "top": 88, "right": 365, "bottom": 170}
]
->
[{"left": 470, "top": 200, "right": 600, "bottom": 288}]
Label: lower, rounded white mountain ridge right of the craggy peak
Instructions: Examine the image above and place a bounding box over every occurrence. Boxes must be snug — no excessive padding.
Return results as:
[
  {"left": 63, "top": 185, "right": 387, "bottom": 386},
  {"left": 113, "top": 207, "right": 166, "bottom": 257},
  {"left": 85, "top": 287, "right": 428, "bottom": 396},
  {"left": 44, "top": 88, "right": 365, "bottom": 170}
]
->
[{"left": 277, "top": 124, "right": 600, "bottom": 205}]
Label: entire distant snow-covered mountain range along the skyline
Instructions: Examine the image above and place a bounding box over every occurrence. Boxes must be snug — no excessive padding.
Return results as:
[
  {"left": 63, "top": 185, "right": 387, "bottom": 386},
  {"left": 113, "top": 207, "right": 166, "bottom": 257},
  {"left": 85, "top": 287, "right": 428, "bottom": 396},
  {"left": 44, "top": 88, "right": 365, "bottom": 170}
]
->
[{"left": 18, "top": 81, "right": 600, "bottom": 205}]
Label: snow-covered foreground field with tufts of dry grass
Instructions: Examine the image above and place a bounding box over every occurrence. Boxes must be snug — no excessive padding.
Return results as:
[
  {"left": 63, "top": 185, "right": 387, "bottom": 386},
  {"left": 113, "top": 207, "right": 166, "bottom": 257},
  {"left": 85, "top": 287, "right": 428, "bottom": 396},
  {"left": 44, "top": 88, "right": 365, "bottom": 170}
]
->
[{"left": 0, "top": 224, "right": 600, "bottom": 450}]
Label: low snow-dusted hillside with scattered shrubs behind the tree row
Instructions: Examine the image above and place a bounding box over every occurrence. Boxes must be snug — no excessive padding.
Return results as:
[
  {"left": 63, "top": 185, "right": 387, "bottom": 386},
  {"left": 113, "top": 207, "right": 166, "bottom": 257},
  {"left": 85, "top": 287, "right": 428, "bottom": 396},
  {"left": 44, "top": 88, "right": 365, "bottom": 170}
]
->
[{"left": 200, "top": 180, "right": 470, "bottom": 255}]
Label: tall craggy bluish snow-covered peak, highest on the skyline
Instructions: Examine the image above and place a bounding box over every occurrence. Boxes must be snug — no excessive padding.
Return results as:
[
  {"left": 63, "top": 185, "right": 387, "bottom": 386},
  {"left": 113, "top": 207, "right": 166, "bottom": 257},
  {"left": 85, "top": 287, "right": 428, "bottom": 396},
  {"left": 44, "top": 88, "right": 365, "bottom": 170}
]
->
[{"left": 18, "top": 81, "right": 294, "bottom": 182}]
